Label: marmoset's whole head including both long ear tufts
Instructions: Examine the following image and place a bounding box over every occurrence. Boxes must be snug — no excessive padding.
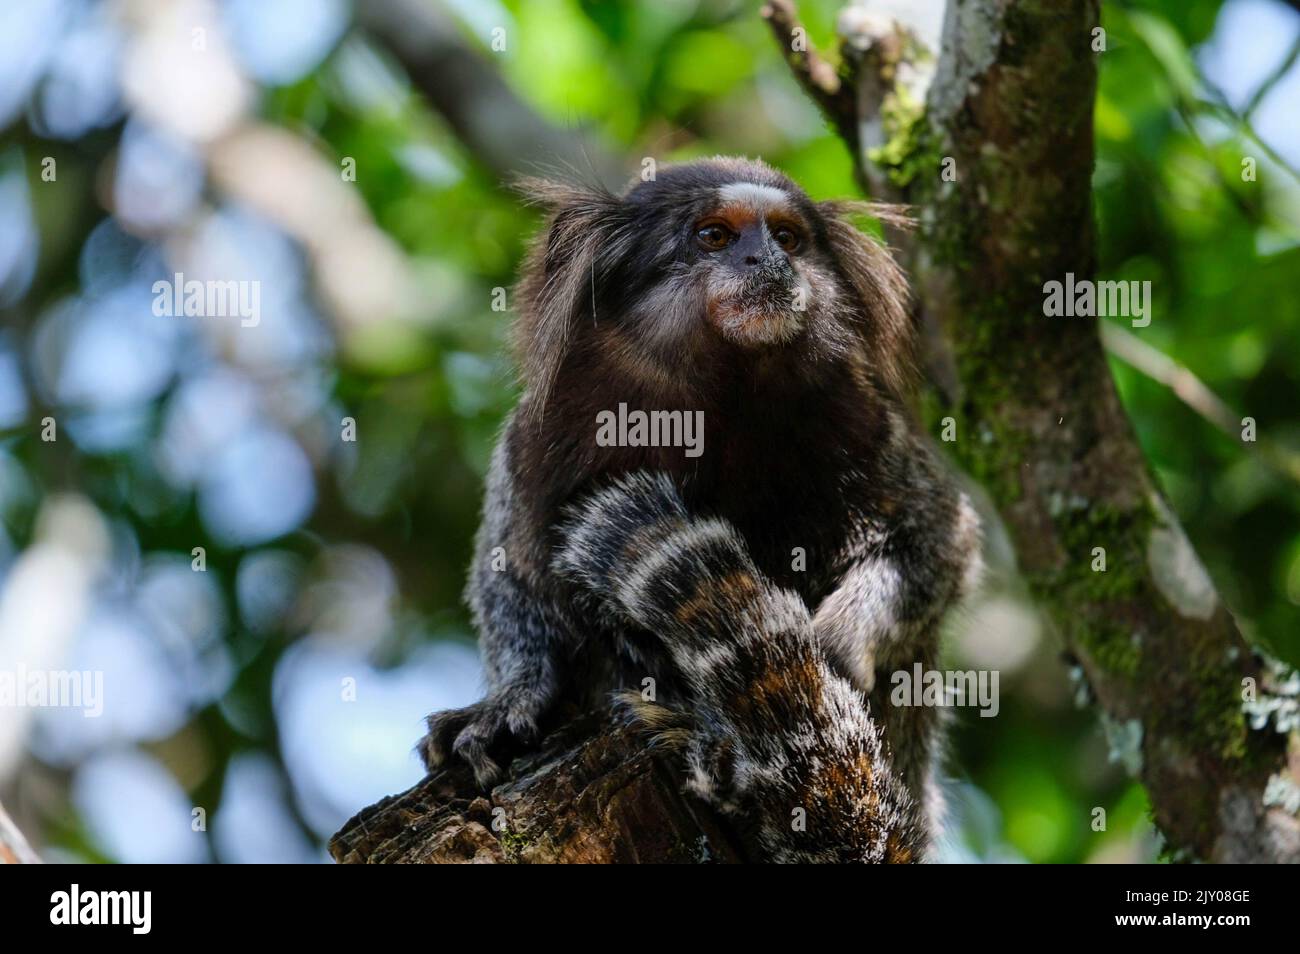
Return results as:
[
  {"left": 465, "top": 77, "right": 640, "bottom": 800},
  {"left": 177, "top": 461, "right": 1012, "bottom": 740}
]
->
[{"left": 517, "top": 159, "right": 910, "bottom": 408}]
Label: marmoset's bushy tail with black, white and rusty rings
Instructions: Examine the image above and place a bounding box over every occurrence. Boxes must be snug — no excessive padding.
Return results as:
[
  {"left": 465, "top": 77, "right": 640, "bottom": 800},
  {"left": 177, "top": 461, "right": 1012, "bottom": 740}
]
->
[{"left": 559, "top": 473, "right": 919, "bottom": 862}]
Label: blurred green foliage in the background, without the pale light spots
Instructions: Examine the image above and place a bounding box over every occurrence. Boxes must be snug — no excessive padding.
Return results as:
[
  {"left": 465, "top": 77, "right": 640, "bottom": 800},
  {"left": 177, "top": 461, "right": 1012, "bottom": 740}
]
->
[{"left": 0, "top": 0, "right": 1300, "bottom": 862}]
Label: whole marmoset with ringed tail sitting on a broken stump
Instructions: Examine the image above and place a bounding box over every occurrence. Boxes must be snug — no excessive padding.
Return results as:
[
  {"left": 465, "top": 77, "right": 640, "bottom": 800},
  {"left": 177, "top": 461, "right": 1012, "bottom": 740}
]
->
[{"left": 420, "top": 157, "right": 979, "bottom": 862}]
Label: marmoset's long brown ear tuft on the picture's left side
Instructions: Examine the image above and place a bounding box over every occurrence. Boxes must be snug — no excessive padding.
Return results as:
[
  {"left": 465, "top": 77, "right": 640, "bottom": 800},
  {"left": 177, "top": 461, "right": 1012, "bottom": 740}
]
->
[{"left": 515, "top": 178, "right": 625, "bottom": 416}]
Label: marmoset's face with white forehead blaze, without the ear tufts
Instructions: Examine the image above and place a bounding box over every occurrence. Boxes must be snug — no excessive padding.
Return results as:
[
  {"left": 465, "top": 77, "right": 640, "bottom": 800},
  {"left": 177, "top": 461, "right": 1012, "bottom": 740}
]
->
[{"left": 625, "top": 160, "right": 839, "bottom": 348}]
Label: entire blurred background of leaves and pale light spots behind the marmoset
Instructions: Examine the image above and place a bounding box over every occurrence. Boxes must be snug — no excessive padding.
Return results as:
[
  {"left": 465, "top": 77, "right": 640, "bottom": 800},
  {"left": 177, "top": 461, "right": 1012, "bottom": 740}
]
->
[{"left": 0, "top": 0, "right": 1300, "bottom": 862}]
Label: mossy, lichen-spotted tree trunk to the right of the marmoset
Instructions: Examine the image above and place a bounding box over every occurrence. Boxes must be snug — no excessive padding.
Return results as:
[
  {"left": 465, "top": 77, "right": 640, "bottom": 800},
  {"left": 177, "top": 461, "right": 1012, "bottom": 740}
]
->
[{"left": 859, "top": 0, "right": 1300, "bottom": 862}]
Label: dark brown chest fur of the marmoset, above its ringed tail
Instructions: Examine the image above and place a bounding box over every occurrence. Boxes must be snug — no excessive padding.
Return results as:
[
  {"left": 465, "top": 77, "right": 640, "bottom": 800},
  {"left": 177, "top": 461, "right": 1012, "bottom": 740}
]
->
[{"left": 519, "top": 376, "right": 889, "bottom": 607}]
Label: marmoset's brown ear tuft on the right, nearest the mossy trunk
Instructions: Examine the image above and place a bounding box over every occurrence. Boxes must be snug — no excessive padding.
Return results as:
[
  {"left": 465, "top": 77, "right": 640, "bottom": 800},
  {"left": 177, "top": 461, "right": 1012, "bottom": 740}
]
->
[{"left": 818, "top": 201, "right": 915, "bottom": 398}]
